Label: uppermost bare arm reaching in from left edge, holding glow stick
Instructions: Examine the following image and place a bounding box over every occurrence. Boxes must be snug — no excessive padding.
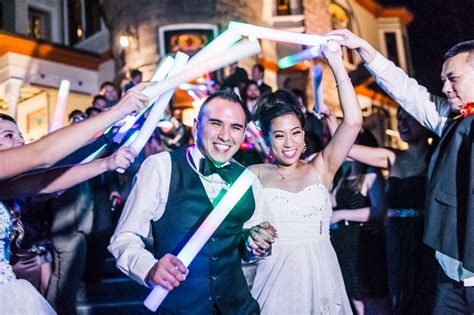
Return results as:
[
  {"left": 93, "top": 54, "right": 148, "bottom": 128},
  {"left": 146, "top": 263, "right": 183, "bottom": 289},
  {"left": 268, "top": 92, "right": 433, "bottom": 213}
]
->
[{"left": 0, "top": 90, "right": 148, "bottom": 180}]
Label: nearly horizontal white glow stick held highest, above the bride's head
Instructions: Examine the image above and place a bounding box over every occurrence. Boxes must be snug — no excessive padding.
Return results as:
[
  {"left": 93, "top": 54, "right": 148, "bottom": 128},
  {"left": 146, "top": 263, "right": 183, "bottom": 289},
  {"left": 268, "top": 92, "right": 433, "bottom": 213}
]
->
[{"left": 229, "top": 21, "right": 343, "bottom": 46}]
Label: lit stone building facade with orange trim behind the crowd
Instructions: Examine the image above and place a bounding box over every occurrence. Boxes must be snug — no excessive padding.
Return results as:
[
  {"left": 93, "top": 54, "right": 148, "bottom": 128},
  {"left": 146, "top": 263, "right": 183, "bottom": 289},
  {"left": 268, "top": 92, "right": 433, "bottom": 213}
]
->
[{"left": 0, "top": 0, "right": 413, "bottom": 146}]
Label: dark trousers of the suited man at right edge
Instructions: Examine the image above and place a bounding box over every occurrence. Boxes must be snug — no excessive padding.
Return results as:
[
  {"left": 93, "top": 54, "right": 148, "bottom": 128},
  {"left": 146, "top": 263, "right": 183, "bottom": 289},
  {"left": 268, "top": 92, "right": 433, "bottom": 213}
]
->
[{"left": 433, "top": 267, "right": 474, "bottom": 315}]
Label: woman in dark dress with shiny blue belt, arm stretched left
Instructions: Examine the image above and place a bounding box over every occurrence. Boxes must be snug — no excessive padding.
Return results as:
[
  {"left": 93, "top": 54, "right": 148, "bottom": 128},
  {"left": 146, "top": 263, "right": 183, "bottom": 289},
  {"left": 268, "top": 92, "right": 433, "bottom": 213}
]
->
[{"left": 349, "top": 110, "right": 436, "bottom": 315}]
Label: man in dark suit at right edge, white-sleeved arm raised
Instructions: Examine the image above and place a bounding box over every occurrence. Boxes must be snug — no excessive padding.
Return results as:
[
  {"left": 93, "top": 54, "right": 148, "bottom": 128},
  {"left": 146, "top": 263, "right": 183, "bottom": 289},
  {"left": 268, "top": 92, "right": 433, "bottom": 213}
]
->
[{"left": 330, "top": 30, "right": 474, "bottom": 314}]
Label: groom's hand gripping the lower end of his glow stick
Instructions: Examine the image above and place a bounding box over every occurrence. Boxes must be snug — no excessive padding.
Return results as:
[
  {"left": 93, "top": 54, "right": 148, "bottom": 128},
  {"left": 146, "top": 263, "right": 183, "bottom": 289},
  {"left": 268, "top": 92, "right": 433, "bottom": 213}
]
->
[{"left": 145, "top": 254, "right": 189, "bottom": 291}]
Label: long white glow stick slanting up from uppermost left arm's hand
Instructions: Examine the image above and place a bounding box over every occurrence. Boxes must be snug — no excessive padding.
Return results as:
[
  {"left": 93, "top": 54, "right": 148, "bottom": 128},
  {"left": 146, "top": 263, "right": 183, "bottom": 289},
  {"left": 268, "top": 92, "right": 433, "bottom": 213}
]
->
[{"left": 141, "top": 41, "right": 260, "bottom": 102}]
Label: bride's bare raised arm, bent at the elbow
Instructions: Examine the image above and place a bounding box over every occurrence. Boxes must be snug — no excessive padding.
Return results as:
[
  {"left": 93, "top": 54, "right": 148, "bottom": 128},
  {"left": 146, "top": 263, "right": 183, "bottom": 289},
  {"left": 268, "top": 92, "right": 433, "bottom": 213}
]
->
[{"left": 312, "top": 43, "right": 362, "bottom": 187}]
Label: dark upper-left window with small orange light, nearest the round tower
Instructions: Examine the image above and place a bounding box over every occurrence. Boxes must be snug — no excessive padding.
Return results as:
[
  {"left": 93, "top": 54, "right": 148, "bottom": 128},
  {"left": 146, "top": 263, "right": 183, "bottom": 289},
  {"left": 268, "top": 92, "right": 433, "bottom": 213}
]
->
[{"left": 66, "top": 0, "right": 101, "bottom": 46}]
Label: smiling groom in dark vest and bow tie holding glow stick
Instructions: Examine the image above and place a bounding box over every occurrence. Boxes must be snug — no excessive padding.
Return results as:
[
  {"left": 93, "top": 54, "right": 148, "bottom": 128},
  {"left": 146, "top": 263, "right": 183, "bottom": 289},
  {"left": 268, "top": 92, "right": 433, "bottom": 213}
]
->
[{"left": 109, "top": 90, "right": 275, "bottom": 314}]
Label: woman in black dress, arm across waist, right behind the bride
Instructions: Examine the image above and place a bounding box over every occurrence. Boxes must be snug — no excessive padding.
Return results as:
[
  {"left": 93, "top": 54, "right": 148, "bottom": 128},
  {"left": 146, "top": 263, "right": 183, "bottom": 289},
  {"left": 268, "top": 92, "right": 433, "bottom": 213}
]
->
[{"left": 331, "top": 130, "right": 385, "bottom": 314}]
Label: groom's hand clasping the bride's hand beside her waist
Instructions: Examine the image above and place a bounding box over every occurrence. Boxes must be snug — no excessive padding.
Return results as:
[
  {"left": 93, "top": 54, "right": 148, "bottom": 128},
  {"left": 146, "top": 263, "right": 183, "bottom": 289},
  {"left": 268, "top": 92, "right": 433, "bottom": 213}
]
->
[{"left": 246, "top": 222, "right": 278, "bottom": 257}]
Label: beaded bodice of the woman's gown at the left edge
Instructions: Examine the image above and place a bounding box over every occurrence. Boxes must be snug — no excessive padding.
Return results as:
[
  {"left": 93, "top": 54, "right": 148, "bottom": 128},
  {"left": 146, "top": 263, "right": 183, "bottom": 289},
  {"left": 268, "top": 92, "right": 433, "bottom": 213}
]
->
[{"left": 0, "top": 202, "right": 15, "bottom": 283}]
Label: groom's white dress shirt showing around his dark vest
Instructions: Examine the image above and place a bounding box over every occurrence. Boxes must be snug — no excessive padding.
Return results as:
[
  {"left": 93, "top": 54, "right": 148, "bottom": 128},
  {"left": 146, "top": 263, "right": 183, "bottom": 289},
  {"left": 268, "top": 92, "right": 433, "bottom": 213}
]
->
[{"left": 109, "top": 147, "right": 262, "bottom": 285}]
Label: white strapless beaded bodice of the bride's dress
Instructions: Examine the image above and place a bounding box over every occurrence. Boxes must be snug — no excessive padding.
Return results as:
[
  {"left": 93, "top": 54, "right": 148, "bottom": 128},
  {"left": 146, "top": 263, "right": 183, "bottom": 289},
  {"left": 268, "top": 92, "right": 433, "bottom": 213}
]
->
[{"left": 263, "top": 184, "right": 332, "bottom": 241}]
